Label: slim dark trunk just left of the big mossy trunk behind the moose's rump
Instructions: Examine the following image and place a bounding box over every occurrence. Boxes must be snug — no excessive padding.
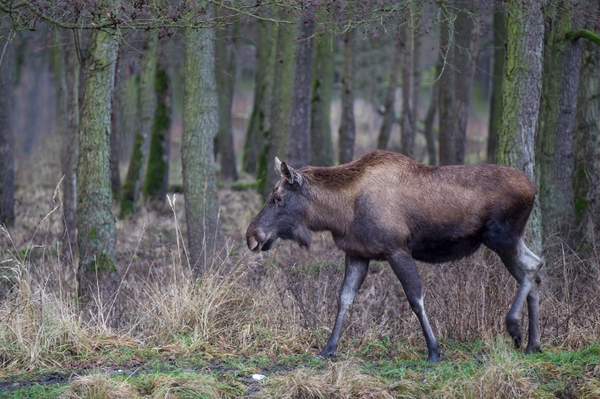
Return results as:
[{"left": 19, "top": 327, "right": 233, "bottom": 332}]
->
[{"left": 487, "top": 4, "right": 506, "bottom": 163}]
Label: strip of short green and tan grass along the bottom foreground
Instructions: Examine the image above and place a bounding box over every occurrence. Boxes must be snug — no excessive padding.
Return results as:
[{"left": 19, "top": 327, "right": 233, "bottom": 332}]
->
[{"left": 0, "top": 341, "right": 600, "bottom": 399}]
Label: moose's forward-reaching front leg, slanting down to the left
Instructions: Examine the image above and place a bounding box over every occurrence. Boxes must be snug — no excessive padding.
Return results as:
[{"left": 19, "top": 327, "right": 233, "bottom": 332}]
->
[{"left": 319, "top": 254, "right": 369, "bottom": 358}]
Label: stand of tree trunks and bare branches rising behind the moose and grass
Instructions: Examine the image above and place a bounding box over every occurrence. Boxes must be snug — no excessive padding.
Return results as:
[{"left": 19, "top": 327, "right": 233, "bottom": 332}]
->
[{"left": 0, "top": 0, "right": 600, "bottom": 304}]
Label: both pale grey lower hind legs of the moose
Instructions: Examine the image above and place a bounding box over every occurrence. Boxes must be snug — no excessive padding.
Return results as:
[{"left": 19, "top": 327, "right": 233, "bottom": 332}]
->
[{"left": 498, "top": 239, "right": 543, "bottom": 352}]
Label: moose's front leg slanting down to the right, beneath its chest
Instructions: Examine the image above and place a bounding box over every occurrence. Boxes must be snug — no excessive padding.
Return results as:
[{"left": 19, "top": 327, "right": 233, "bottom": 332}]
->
[{"left": 388, "top": 252, "right": 443, "bottom": 363}]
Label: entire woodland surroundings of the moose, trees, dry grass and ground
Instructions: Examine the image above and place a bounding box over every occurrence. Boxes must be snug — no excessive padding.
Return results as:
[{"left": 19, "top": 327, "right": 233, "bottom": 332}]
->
[{"left": 0, "top": 0, "right": 600, "bottom": 398}]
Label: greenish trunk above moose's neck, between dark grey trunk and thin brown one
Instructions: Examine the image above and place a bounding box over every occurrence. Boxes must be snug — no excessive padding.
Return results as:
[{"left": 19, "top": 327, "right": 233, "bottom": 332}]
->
[{"left": 310, "top": 26, "right": 335, "bottom": 166}]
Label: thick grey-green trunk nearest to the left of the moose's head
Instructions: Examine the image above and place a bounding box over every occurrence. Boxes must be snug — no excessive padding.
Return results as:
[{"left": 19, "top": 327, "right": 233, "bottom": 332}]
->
[{"left": 181, "top": 10, "right": 224, "bottom": 276}]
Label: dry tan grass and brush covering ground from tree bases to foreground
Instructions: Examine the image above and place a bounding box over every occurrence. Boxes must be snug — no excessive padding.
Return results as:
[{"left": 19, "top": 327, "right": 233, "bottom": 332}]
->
[{"left": 0, "top": 168, "right": 600, "bottom": 398}]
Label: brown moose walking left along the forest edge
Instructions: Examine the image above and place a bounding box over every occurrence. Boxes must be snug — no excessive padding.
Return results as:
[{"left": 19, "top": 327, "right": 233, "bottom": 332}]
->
[{"left": 246, "top": 150, "right": 543, "bottom": 363}]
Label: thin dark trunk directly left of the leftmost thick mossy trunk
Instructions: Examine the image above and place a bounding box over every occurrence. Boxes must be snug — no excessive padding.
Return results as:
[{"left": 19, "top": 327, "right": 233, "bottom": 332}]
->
[{"left": 53, "top": 29, "right": 80, "bottom": 253}]
